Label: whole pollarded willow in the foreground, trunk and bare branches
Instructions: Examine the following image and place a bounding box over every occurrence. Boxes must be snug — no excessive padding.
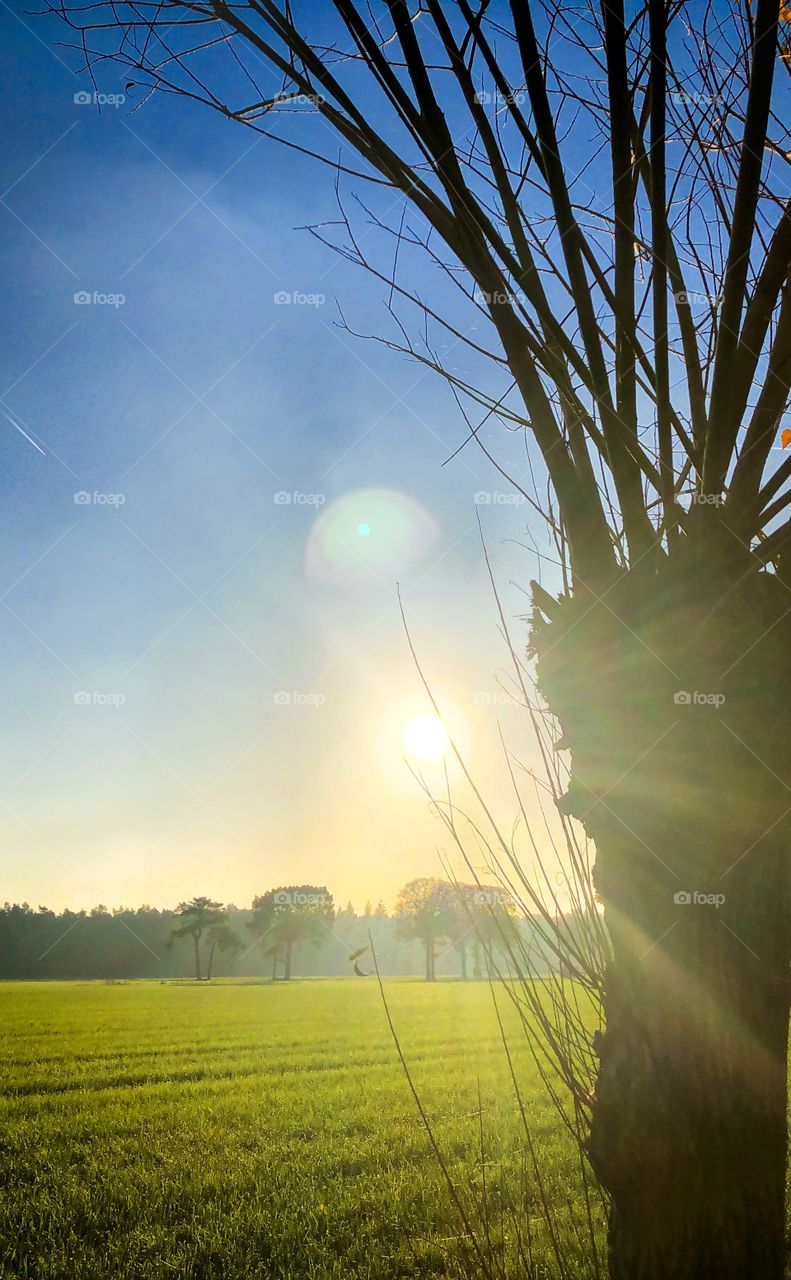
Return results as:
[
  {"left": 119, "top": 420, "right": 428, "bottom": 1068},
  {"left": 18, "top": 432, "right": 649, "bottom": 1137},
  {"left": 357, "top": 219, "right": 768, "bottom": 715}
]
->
[{"left": 55, "top": 0, "right": 791, "bottom": 1280}]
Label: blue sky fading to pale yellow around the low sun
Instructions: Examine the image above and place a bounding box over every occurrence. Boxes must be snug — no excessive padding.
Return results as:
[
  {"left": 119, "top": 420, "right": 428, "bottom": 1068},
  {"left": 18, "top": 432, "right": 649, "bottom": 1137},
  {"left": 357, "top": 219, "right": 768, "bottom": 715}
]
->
[{"left": 0, "top": 5, "right": 565, "bottom": 908}]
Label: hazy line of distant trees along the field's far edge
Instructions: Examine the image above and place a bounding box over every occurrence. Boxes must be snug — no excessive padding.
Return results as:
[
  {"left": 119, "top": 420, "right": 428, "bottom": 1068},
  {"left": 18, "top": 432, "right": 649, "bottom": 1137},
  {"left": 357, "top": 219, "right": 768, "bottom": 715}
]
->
[{"left": 0, "top": 877, "right": 547, "bottom": 982}]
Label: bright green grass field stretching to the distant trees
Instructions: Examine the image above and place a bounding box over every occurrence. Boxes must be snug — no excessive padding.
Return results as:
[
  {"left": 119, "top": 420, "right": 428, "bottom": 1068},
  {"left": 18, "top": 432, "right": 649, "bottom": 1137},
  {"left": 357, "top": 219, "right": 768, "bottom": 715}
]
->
[{"left": 0, "top": 979, "right": 593, "bottom": 1280}]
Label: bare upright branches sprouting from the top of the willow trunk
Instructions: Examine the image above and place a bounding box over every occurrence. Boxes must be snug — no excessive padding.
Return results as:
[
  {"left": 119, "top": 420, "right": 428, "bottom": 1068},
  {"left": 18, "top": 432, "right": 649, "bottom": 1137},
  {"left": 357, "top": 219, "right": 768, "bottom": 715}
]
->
[{"left": 50, "top": 0, "right": 791, "bottom": 588}]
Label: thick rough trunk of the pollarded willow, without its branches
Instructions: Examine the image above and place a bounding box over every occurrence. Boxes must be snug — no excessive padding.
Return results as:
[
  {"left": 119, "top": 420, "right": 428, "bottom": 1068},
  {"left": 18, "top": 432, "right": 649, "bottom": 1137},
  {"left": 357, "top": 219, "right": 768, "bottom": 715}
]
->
[{"left": 534, "top": 550, "right": 791, "bottom": 1280}]
